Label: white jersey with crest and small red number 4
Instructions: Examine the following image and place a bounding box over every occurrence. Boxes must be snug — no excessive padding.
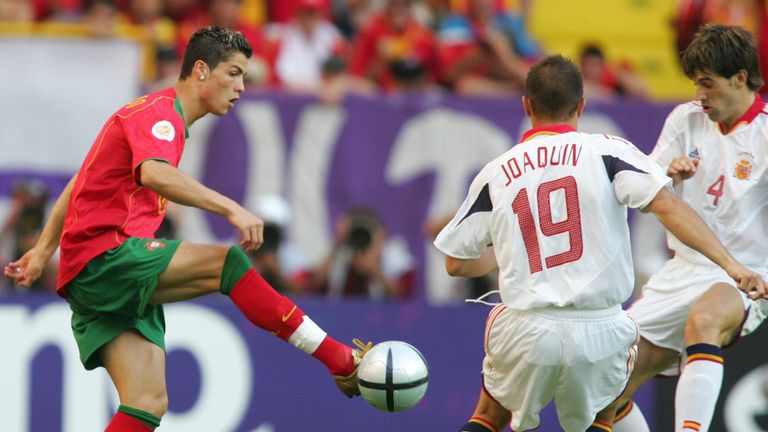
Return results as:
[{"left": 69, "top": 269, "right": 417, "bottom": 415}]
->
[{"left": 651, "top": 97, "right": 768, "bottom": 267}]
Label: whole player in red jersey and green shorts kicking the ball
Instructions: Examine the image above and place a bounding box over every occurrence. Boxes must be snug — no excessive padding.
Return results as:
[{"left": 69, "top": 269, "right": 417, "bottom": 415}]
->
[{"left": 4, "top": 27, "right": 370, "bottom": 432}]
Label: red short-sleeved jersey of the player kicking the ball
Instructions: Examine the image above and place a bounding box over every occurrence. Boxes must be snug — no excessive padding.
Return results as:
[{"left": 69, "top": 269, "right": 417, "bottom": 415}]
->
[{"left": 57, "top": 88, "right": 186, "bottom": 297}]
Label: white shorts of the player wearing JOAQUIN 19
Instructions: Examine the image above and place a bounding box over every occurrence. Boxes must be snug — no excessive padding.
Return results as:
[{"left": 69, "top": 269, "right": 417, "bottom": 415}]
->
[{"left": 483, "top": 305, "right": 638, "bottom": 432}]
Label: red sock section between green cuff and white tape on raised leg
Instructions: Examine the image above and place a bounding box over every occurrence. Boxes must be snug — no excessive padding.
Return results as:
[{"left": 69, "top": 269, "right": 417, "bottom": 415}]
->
[{"left": 229, "top": 269, "right": 304, "bottom": 340}]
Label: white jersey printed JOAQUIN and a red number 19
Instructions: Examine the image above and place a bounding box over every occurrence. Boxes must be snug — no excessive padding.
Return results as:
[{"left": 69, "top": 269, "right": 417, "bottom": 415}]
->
[{"left": 435, "top": 125, "right": 671, "bottom": 310}]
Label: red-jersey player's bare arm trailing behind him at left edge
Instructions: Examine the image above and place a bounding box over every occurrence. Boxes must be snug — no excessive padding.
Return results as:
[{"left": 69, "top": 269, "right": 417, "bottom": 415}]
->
[{"left": 3, "top": 174, "right": 77, "bottom": 288}]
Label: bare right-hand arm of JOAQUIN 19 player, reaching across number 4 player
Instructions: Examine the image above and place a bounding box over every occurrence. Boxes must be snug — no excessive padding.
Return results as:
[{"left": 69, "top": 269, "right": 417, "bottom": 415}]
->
[{"left": 646, "top": 189, "right": 765, "bottom": 299}]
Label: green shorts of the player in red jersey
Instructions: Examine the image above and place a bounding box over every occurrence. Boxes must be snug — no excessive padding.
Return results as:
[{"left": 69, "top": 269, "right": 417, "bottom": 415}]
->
[{"left": 66, "top": 238, "right": 181, "bottom": 370}]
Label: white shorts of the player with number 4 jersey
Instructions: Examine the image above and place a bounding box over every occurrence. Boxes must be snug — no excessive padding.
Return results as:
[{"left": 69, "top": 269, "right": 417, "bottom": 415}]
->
[{"left": 628, "top": 258, "right": 768, "bottom": 375}]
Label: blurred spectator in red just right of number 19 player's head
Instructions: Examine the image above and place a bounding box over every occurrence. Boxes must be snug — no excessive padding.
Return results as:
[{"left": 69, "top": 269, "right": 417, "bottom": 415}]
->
[{"left": 580, "top": 44, "right": 648, "bottom": 100}]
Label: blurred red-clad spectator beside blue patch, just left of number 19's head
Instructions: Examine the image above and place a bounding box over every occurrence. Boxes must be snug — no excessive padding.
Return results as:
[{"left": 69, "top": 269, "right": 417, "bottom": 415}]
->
[{"left": 438, "top": 0, "right": 538, "bottom": 96}]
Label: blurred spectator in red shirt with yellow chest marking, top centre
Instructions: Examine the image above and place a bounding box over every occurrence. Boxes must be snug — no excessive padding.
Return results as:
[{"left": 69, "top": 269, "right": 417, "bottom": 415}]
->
[{"left": 350, "top": 0, "right": 438, "bottom": 90}]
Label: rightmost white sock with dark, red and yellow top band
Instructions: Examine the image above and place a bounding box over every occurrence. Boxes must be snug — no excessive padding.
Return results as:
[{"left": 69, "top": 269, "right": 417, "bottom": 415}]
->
[{"left": 675, "top": 344, "right": 723, "bottom": 432}]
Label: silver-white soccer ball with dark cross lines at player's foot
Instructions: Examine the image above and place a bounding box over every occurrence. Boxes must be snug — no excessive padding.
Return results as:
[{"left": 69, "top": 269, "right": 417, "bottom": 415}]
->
[{"left": 357, "top": 341, "right": 429, "bottom": 412}]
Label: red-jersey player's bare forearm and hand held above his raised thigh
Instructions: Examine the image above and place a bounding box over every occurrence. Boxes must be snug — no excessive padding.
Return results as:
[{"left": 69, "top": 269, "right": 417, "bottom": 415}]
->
[{"left": 141, "top": 160, "right": 264, "bottom": 252}]
